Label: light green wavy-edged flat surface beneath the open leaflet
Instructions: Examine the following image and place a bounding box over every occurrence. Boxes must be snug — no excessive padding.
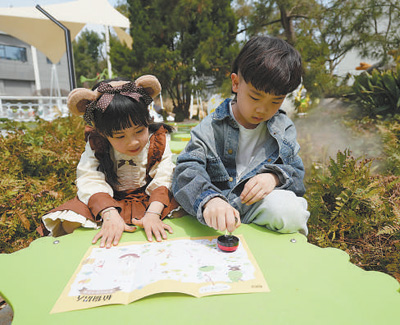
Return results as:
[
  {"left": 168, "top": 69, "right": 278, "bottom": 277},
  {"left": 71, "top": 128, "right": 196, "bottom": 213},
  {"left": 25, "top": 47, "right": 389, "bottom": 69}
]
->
[{"left": 0, "top": 216, "right": 400, "bottom": 325}]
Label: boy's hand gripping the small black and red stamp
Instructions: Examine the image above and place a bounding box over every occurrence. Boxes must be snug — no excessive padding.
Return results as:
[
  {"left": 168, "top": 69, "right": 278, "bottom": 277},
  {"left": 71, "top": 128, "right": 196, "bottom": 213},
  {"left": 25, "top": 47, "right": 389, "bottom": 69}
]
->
[{"left": 203, "top": 197, "right": 240, "bottom": 232}]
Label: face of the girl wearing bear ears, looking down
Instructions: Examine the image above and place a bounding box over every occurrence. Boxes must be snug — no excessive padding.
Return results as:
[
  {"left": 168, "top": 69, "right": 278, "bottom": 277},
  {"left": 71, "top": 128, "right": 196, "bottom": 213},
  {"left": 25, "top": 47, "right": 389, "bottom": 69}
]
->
[{"left": 107, "top": 124, "right": 149, "bottom": 156}]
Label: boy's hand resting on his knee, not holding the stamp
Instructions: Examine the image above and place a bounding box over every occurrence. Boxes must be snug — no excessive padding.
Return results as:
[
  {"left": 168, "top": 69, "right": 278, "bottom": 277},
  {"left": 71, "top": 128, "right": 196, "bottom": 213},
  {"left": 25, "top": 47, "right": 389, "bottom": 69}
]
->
[{"left": 240, "top": 173, "right": 279, "bottom": 205}]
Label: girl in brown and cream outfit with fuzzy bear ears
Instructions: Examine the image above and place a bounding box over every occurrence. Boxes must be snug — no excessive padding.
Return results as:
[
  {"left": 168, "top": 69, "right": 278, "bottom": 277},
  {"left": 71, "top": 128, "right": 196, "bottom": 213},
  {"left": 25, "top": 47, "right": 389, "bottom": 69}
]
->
[{"left": 42, "top": 75, "right": 178, "bottom": 248}]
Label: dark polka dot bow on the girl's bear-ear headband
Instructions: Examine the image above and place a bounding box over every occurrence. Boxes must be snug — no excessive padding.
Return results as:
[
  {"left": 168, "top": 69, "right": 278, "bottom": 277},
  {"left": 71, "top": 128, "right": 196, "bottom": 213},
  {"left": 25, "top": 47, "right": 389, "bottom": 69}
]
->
[{"left": 84, "top": 82, "right": 153, "bottom": 124}]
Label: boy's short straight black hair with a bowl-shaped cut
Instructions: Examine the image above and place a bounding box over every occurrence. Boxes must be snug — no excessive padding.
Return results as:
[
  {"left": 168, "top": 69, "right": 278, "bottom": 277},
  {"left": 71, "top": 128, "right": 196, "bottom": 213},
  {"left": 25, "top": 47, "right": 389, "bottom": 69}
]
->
[{"left": 232, "top": 36, "right": 302, "bottom": 95}]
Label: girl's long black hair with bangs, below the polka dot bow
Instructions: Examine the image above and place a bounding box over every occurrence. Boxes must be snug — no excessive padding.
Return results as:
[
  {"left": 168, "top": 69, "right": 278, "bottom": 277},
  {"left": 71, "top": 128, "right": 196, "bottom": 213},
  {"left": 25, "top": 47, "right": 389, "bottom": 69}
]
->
[{"left": 93, "top": 78, "right": 173, "bottom": 187}]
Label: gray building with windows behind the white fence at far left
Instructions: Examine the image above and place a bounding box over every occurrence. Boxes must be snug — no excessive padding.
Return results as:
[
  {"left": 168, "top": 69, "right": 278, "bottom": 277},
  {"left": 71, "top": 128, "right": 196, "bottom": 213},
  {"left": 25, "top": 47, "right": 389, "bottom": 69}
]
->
[{"left": 0, "top": 32, "right": 70, "bottom": 96}]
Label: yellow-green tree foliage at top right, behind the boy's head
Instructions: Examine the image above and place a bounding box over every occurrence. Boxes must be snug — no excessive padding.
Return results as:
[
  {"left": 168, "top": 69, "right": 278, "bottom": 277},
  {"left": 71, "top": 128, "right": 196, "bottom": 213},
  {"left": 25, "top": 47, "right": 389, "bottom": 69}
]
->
[{"left": 237, "top": 0, "right": 400, "bottom": 97}]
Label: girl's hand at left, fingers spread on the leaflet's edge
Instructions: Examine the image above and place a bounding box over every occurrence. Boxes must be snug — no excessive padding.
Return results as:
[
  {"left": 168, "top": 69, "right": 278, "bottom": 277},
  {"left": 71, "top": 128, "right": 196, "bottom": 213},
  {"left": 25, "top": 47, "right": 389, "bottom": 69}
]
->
[{"left": 92, "top": 209, "right": 137, "bottom": 248}]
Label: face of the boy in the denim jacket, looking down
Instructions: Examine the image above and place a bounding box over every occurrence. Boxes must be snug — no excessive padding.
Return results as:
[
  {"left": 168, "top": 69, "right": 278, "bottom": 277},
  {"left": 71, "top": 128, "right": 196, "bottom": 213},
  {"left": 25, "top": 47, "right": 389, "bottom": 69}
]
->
[{"left": 231, "top": 73, "right": 286, "bottom": 129}]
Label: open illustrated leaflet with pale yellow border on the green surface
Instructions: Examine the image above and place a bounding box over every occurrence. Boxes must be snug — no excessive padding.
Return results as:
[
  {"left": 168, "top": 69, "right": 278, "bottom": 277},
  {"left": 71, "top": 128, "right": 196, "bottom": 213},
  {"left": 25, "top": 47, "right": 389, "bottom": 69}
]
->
[{"left": 51, "top": 235, "right": 269, "bottom": 313}]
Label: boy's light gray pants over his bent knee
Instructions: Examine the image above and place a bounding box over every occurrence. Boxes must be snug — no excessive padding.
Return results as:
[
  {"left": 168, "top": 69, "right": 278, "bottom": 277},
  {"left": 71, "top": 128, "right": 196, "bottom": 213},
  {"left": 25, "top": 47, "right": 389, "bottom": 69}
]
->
[{"left": 235, "top": 190, "right": 310, "bottom": 236}]
